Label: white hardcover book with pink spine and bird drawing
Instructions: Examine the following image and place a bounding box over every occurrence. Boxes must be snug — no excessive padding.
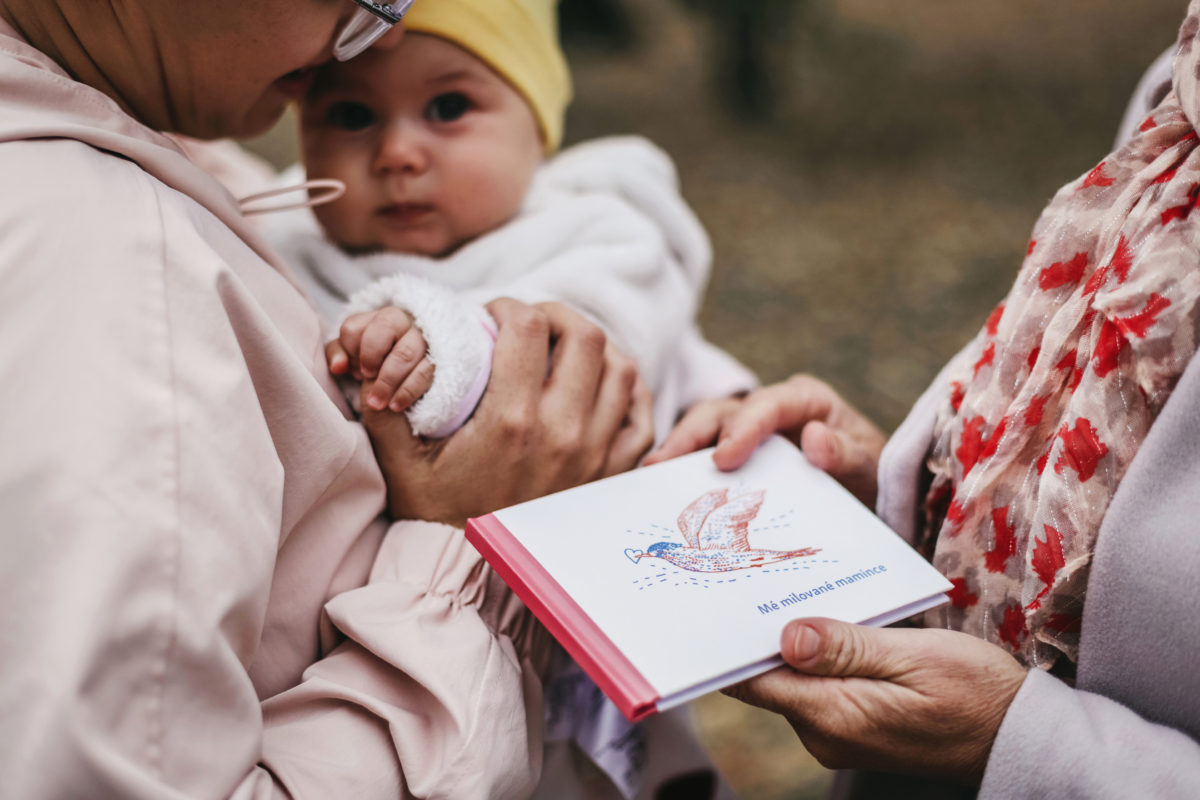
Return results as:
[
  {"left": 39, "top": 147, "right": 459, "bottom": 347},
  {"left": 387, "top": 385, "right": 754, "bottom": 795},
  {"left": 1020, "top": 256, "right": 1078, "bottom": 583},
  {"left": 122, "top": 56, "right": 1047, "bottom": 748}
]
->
[{"left": 467, "top": 435, "right": 952, "bottom": 721}]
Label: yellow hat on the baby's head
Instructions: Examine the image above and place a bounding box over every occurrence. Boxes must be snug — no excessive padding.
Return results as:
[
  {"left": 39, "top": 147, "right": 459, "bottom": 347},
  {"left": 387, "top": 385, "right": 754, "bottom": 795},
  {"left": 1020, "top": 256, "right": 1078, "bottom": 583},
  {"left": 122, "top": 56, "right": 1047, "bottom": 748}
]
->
[{"left": 404, "top": 0, "right": 571, "bottom": 154}]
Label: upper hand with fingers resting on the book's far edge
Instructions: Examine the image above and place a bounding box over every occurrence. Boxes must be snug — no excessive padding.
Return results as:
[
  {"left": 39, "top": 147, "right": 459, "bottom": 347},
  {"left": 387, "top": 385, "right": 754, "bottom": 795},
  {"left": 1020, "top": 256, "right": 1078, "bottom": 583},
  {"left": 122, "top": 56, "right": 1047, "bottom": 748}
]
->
[{"left": 646, "top": 375, "right": 887, "bottom": 507}]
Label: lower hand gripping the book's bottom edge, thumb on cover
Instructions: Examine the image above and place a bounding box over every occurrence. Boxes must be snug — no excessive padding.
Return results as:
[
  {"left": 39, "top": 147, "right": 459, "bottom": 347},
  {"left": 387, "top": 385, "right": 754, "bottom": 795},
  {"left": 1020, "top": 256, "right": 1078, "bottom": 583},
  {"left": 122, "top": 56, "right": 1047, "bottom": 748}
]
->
[{"left": 725, "top": 619, "right": 1025, "bottom": 786}]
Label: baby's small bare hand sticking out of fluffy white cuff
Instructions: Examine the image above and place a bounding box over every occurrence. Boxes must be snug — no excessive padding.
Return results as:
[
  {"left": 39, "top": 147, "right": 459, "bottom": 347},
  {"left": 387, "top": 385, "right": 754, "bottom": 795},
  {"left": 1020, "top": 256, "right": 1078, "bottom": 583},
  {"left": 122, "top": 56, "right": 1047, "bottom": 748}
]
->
[{"left": 325, "top": 307, "right": 433, "bottom": 411}]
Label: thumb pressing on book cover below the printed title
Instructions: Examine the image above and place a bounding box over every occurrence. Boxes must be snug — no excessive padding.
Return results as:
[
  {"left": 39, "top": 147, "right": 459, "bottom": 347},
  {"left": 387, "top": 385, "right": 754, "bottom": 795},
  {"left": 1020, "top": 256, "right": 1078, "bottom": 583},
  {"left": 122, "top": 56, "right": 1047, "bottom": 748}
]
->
[{"left": 780, "top": 618, "right": 895, "bottom": 678}]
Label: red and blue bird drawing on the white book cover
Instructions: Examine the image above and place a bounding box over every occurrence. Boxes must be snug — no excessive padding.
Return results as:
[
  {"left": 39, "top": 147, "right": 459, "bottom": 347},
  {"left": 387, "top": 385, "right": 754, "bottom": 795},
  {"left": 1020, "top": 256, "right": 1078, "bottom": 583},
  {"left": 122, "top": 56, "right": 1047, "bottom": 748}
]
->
[{"left": 625, "top": 489, "right": 820, "bottom": 572}]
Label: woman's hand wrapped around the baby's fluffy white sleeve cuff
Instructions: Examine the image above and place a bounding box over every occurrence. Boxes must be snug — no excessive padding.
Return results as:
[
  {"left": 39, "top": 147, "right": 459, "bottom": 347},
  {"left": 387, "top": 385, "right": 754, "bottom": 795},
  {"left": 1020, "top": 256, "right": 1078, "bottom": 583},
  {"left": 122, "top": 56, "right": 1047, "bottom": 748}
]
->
[{"left": 362, "top": 299, "right": 654, "bottom": 527}]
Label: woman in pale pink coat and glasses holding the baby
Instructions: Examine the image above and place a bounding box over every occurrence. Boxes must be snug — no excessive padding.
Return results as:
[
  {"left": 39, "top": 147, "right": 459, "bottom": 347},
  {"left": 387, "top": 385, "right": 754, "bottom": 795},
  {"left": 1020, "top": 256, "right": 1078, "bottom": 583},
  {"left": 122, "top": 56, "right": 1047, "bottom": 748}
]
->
[{"left": 0, "top": 0, "right": 650, "bottom": 798}]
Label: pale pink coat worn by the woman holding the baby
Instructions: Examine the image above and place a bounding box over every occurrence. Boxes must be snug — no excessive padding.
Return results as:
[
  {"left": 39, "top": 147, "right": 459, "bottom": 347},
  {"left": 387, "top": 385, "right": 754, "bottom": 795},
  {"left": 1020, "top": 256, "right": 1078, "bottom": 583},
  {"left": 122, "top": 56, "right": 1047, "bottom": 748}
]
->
[{"left": 0, "top": 23, "right": 541, "bottom": 799}]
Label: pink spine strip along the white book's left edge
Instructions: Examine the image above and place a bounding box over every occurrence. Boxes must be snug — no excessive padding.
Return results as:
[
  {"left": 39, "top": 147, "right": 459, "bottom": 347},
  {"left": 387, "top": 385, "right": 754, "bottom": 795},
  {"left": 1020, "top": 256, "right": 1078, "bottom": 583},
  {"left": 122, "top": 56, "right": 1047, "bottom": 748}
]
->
[{"left": 467, "top": 515, "right": 659, "bottom": 722}]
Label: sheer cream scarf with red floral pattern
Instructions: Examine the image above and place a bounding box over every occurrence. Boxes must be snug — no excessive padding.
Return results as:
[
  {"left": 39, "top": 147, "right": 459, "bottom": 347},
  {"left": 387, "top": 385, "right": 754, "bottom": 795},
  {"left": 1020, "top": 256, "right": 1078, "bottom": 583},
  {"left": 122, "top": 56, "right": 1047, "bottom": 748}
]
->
[{"left": 919, "top": 0, "right": 1200, "bottom": 672}]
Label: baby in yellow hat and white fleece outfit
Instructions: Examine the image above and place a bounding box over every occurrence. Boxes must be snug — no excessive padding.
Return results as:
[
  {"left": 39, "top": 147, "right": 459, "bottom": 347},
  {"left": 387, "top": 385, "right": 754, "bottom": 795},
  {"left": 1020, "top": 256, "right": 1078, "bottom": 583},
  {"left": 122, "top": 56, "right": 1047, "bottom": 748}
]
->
[{"left": 268, "top": 0, "right": 755, "bottom": 796}]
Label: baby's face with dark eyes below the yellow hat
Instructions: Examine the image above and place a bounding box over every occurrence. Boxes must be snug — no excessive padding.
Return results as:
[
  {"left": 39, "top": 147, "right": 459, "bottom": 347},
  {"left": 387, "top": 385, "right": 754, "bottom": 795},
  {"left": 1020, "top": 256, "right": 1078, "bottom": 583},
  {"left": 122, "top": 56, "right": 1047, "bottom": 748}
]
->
[{"left": 301, "top": 34, "right": 542, "bottom": 255}]
